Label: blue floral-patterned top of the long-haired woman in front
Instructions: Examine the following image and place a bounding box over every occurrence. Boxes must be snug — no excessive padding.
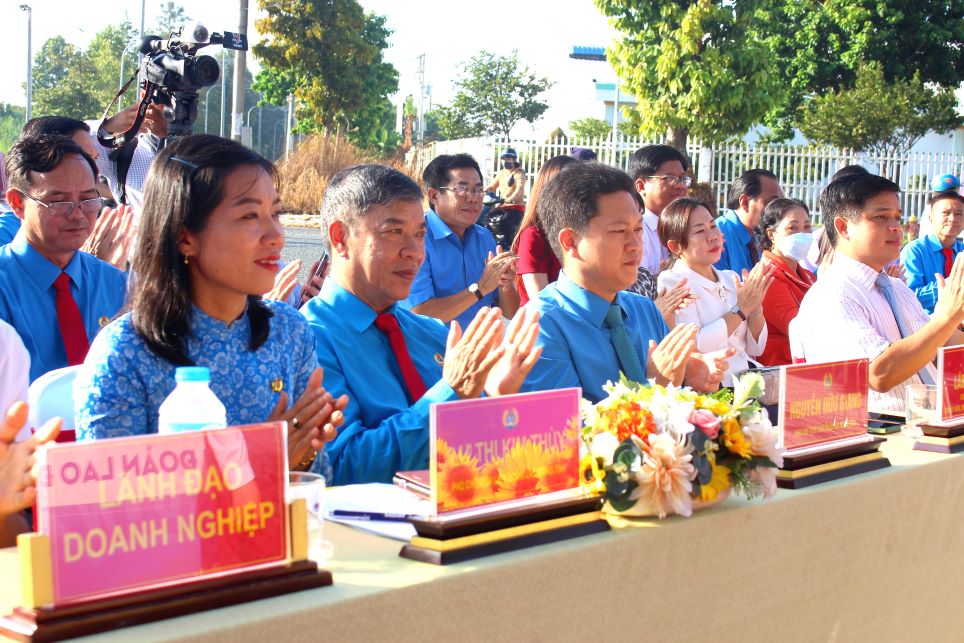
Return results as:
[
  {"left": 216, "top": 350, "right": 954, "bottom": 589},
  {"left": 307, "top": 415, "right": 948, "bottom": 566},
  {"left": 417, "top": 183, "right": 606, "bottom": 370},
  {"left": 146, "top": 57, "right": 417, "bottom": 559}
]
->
[{"left": 74, "top": 301, "right": 331, "bottom": 479}]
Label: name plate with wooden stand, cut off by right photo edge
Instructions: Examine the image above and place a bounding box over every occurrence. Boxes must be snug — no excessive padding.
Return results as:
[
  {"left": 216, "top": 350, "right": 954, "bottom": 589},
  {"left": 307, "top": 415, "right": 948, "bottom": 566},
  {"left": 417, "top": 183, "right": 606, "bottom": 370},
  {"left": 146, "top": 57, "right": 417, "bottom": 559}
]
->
[{"left": 914, "top": 346, "right": 964, "bottom": 453}]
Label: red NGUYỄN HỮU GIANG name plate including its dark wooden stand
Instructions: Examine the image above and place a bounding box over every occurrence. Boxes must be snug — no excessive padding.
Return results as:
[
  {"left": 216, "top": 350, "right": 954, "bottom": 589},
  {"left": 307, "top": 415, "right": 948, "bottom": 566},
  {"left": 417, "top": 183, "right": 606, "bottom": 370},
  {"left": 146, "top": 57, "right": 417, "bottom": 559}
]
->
[{"left": 777, "top": 359, "right": 890, "bottom": 489}]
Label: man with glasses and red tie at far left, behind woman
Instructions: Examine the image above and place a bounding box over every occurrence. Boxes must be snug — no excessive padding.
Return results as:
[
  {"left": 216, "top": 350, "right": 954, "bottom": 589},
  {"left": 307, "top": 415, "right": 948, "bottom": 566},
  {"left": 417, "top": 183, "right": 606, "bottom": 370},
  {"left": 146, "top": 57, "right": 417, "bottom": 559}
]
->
[{"left": 0, "top": 136, "right": 127, "bottom": 382}]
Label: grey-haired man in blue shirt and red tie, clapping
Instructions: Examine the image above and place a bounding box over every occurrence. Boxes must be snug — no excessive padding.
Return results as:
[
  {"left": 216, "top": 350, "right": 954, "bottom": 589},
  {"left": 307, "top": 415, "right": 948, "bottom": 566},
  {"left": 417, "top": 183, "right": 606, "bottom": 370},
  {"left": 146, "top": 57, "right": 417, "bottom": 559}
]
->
[{"left": 301, "top": 165, "right": 539, "bottom": 485}]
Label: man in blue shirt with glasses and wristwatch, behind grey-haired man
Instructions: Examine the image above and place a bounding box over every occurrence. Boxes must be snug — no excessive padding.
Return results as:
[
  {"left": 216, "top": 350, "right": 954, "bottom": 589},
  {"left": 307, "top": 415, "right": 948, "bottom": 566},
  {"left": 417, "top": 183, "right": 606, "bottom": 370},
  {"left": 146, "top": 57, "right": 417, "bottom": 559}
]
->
[{"left": 405, "top": 154, "right": 519, "bottom": 327}]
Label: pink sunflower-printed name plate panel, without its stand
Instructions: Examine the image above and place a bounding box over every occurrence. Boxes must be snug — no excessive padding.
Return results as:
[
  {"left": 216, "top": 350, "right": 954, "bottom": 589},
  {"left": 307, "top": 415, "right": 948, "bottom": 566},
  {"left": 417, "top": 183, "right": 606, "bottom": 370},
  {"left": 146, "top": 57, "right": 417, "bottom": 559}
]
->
[{"left": 429, "top": 388, "right": 580, "bottom": 513}]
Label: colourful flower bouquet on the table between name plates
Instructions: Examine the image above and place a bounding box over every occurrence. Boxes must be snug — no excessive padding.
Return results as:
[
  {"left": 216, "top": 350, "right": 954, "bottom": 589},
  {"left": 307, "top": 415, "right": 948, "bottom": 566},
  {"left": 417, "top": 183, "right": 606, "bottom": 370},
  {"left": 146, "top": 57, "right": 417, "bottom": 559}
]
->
[{"left": 580, "top": 373, "right": 783, "bottom": 518}]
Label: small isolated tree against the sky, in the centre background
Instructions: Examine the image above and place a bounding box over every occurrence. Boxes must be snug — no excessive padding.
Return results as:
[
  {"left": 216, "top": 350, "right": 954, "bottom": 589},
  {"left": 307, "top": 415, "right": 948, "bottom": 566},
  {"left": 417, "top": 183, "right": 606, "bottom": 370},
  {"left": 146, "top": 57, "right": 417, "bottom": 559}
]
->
[{"left": 436, "top": 51, "right": 552, "bottom": 138}]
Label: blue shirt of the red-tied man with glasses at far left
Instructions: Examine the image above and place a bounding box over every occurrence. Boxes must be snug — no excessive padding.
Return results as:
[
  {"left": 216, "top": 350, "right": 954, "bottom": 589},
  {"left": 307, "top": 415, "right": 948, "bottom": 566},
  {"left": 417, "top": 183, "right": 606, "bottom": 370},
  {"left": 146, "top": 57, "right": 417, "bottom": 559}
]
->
[{"left": 0, "top": 231, "right": 127, "bottom": 382}]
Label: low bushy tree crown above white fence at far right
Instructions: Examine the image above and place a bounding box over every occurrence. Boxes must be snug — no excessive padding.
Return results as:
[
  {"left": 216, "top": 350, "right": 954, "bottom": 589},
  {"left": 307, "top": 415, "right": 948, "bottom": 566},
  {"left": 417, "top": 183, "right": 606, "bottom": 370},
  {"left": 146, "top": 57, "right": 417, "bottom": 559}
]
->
[{"left": 800, "top": 64, "right": 964, "bottom": 156}]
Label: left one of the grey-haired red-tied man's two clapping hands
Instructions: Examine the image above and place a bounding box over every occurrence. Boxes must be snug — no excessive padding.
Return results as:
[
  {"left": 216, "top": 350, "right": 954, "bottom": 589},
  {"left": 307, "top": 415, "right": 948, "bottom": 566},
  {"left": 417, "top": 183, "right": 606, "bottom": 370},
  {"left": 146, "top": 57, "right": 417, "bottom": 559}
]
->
[{"left": 442, "top": 306, "right": 506, "bottom": 400}]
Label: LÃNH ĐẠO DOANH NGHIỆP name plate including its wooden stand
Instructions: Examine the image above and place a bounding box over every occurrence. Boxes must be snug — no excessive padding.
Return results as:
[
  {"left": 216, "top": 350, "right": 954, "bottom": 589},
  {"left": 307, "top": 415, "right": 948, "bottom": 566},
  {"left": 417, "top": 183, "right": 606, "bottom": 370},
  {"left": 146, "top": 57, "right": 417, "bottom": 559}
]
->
[{"left": 0, "top": 423, "right": 332, "bottom": 641}]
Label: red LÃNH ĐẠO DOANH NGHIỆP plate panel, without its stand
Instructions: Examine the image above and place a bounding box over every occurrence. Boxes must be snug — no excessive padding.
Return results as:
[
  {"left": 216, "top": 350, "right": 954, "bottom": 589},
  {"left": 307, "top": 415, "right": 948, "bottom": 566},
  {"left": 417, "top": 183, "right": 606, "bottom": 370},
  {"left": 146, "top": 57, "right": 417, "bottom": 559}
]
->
[{"left": 37, "top": 422, "right": 287, "bottom": 605}]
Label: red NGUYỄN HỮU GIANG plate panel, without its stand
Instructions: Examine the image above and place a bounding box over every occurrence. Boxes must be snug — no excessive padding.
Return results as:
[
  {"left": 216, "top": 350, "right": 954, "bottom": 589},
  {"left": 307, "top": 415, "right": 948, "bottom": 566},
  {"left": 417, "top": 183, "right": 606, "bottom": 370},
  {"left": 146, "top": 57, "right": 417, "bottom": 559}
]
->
[{"left": 780, "top": 359, "right": 870, "bottom": 450}]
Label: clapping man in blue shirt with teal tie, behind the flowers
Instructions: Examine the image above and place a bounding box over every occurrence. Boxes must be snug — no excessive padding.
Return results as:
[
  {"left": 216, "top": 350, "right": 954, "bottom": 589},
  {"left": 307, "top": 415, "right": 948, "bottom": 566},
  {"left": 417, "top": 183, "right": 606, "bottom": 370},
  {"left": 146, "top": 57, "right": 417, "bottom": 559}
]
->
[{"left": 523, "top": 163, "right": 733, "bottom": 402}]
